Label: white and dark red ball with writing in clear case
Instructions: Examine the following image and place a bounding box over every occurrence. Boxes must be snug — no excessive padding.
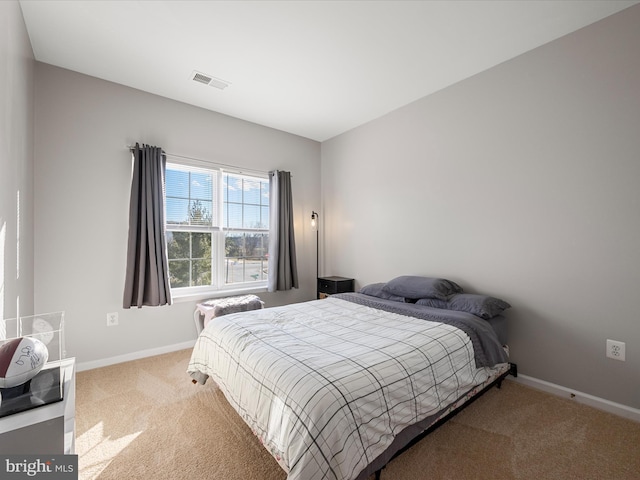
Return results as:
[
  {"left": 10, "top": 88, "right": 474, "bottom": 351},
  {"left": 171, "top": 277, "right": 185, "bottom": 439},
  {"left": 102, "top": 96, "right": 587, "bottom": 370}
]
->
[{"left": 0, "top": 337, "right": 49, "bottom": 388}]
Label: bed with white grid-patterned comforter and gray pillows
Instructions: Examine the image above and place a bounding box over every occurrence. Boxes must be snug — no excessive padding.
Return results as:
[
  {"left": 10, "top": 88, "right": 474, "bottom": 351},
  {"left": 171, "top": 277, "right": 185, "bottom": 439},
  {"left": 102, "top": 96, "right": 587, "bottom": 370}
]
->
[{"left": 188, "top": 277, "right": 513, "bottom": 480}]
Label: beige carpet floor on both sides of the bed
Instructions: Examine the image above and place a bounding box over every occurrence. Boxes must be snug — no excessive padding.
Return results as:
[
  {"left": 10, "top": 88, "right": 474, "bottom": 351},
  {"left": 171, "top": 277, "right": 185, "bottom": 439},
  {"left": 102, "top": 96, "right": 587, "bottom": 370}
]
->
[{"left": 76, "top": 350, "right": 640, "bottom": 480}]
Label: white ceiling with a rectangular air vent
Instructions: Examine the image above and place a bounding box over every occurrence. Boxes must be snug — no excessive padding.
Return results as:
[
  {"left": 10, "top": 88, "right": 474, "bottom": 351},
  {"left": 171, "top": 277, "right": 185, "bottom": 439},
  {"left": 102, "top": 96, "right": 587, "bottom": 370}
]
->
[{"left": 20, "top": 0, "right": 639, "bottom": 141}]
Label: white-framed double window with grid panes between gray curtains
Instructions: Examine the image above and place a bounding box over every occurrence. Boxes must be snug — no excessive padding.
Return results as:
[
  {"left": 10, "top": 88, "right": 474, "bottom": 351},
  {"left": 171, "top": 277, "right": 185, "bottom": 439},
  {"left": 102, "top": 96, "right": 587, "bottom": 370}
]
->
[{"left": 165, "top": 163, "right": 269, "bottom": 295}]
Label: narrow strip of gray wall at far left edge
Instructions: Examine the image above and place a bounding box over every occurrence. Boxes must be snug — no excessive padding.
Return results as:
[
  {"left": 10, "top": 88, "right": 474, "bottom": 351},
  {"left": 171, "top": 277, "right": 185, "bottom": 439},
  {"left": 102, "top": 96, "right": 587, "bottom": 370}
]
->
[{"left": 0, "top": 2, "right": 35, "bottom": 319}]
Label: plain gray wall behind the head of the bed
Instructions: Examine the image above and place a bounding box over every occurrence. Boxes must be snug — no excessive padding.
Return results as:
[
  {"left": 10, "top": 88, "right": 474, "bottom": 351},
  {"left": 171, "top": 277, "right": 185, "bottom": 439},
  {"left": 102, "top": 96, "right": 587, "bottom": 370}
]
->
[{"left": 321, "top": 6, "right": 640, "bottom": 408}]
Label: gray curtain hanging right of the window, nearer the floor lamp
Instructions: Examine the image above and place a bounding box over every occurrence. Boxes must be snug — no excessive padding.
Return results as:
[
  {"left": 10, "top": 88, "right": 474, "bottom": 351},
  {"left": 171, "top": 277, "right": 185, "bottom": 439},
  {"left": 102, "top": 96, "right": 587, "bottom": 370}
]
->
[{"left": 267, "top": 170, "right": 298, "bottom": 292}]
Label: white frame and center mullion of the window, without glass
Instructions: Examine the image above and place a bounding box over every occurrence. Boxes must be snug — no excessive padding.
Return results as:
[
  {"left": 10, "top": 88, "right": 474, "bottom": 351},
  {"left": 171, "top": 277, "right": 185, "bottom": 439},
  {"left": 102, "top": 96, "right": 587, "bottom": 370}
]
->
[{"left": 165, "top": 158, "right": 269, "bottom": 302}]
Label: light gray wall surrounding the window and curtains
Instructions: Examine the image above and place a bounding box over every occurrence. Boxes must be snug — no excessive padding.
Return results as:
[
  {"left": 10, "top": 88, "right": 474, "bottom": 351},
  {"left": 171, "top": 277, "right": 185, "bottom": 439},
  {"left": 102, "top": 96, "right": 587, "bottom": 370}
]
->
[{"left": 35, "top": 63, "right": 320, "bottom": 364}]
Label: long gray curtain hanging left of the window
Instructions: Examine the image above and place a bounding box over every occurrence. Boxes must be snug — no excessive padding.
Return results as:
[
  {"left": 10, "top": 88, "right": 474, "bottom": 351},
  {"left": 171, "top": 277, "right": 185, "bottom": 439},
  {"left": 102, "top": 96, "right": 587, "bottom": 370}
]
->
[{"left": 122, "top": 143, "right": 171, "bottom": 308}]
